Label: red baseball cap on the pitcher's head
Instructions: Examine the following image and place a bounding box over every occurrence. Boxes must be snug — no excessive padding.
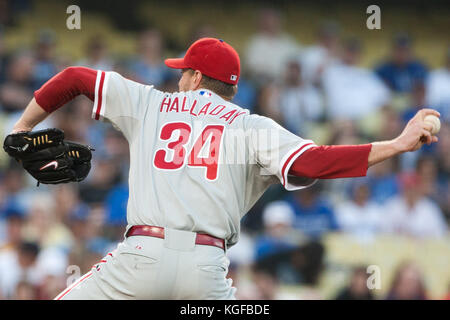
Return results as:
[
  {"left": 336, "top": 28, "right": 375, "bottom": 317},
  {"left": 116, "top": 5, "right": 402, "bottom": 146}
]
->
[{"left": 165, "top": 38, "right": 241, "bottom": 84}]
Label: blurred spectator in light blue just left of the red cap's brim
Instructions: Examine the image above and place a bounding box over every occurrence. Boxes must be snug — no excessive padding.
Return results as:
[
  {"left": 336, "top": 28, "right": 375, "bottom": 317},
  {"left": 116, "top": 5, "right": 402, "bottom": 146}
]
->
[{"left": 129, "top": 29, "right": 170, "bottom": 88}]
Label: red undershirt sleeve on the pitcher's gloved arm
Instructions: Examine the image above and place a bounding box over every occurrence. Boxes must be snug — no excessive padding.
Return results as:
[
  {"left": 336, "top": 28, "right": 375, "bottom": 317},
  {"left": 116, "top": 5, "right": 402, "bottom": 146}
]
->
[{"left": 34, "top": 67, "right": 97, "bottom": 113}]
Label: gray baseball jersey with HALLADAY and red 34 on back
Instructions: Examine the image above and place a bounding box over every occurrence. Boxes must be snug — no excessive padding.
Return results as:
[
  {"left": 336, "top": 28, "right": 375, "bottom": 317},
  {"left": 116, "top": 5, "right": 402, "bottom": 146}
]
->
[{"left": 92, "top": 70, "right": 315, "bottom": 246}]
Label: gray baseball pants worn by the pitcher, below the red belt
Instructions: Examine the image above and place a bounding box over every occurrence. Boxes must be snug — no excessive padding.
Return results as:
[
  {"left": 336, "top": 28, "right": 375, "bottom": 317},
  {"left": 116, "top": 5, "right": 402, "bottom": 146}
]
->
[{"left": 55, "top": 228, "right": 236, "bottom": 300}]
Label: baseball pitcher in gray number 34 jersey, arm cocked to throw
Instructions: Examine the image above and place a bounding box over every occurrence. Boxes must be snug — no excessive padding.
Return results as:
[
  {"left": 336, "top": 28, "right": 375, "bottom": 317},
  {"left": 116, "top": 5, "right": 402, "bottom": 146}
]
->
[{"left": 4, "top": 38, "right": 439, "bottom": 299}]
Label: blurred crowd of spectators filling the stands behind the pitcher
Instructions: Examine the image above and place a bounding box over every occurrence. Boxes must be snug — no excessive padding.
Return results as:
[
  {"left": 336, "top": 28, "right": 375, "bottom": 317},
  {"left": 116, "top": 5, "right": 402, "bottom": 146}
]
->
[{"left": 0, "top": 5, "right": 450, "bottom": 299}]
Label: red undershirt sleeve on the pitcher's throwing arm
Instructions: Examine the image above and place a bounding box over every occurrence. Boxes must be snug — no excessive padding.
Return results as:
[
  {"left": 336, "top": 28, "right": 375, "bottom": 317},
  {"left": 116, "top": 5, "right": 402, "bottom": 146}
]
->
[{"left": 289, "top": 144, "right": 372, "bottom": 179}]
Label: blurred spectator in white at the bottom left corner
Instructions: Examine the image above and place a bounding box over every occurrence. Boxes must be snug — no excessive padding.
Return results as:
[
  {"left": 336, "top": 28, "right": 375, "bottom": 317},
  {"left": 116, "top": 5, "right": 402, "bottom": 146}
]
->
[{"left": 0, "top": 242, "right": 41, "bottom": 298}]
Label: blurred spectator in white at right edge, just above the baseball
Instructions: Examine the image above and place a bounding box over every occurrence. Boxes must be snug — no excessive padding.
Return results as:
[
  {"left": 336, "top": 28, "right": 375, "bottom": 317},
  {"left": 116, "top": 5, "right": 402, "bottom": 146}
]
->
[{"left": 426, "top": 47, "right": 450, "bottom": 122}]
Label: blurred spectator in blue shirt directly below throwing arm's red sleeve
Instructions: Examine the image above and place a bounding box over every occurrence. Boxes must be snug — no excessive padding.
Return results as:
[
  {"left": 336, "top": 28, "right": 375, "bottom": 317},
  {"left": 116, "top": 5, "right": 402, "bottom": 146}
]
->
[{"left": 286, "top": 183, "right": 338, "bottom": 238}]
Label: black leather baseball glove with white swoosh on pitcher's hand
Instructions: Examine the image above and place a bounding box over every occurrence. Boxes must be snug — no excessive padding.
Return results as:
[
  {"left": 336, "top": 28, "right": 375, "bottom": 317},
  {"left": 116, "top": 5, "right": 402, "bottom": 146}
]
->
[{"left": 3, "top": 128, "right": 94, "bottom": 185}]
